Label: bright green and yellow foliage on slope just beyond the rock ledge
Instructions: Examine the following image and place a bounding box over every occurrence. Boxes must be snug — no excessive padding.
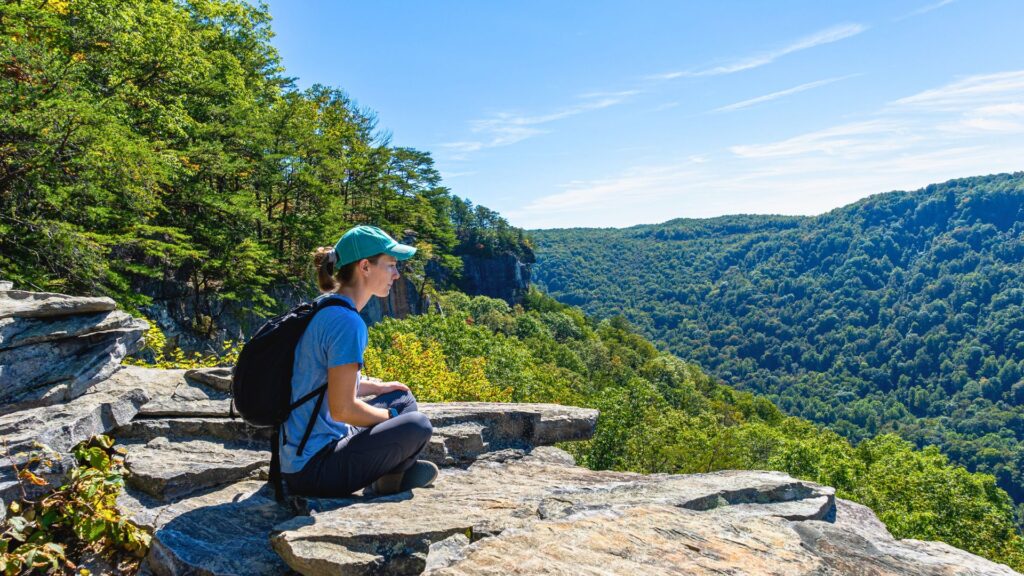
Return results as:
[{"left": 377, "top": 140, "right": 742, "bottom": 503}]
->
[{"left": 367, "top": 290, "right": 1024, "bottom": 570}]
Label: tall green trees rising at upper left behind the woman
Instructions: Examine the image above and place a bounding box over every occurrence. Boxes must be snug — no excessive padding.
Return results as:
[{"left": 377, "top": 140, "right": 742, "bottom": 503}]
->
[{"left": 0, "top": 0, "right": 525, "bottom": 317}]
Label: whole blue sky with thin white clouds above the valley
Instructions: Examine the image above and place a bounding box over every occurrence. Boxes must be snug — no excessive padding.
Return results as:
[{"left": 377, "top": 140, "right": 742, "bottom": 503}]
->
[{"left": 269, "top": 0, "right": 1024, "bottom": 229}]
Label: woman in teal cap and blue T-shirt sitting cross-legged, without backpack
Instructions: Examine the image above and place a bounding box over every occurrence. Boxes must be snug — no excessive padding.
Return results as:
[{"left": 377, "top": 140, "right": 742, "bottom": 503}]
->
[{"left": 281, "top": 225, "right": 437, "bottom": 497}]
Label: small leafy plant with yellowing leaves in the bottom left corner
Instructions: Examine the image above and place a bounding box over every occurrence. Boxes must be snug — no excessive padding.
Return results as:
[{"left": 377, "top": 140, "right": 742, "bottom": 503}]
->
[{"left": 0, "top": 436, "right": 151, "bottom": 575}]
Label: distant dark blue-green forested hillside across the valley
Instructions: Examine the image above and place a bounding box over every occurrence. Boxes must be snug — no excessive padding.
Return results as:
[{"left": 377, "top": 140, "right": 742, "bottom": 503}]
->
[{"left": 532, "top": 173, "right": 1024, "bottom": 510}]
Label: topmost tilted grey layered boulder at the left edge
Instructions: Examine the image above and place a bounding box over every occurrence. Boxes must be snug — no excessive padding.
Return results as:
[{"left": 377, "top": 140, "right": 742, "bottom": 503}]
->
[{"left": 0, "top": 290, "right": 148, "bottom": 403}]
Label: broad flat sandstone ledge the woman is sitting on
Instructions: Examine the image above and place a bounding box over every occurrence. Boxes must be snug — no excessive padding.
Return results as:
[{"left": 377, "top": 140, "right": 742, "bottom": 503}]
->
[{"left": 0, "top": 291, "right": 1016, "bottom": 575}]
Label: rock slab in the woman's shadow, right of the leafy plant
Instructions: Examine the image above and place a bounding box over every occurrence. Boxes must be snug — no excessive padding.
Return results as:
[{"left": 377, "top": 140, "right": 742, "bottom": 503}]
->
[{"left": 119, "top": 482, "right": 292, "bottom": 576}]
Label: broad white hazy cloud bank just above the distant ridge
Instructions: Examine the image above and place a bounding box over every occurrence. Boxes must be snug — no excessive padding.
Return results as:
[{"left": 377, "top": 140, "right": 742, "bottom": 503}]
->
[{"left": 512, "top": 70, "right": 1024, "bottom": 228}]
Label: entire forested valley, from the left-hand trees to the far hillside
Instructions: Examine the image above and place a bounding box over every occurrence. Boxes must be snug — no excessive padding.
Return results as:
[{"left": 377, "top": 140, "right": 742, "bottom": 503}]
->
[{"left": 6, "top": 0, "right": 1024, "bottom": 570}]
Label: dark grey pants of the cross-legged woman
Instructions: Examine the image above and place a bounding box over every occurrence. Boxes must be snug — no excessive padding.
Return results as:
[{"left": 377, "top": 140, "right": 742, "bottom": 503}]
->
[{"left": 283, "top": 390, "right": 433, "bottom": 498}]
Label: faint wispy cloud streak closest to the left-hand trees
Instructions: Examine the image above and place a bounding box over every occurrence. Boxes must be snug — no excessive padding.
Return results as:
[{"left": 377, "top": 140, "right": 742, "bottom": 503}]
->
[{"left": 440, "top": 90, "right": 639, "bottom": 155}]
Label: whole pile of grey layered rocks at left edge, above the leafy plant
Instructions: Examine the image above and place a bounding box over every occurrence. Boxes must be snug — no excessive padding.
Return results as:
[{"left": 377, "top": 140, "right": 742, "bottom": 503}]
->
[{"left": 0, "top": 282, "right": 148, "bottom": 501}]
